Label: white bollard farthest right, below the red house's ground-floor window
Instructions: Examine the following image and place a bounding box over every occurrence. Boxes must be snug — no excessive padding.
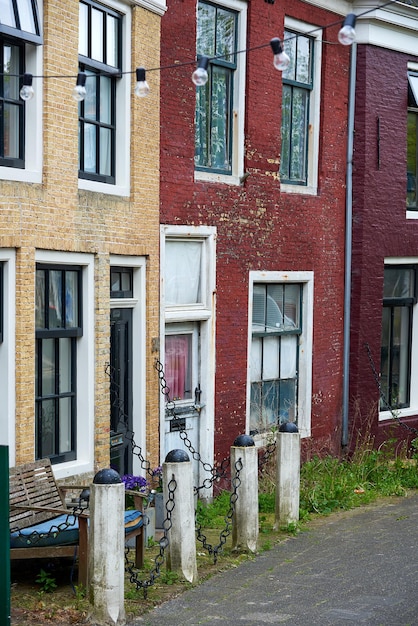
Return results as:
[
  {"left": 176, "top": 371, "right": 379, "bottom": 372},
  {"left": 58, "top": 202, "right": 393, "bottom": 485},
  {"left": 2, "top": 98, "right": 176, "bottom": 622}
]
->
[{"left": 275, "top": 424, "right": 300, "bottom": 529}]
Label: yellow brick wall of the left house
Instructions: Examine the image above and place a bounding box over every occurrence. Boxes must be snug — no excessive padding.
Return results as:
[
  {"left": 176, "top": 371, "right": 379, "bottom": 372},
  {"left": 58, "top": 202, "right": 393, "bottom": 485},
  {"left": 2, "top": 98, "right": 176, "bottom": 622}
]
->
[{"left": 0, "top": 0, "right": 161, "bottom": 473}]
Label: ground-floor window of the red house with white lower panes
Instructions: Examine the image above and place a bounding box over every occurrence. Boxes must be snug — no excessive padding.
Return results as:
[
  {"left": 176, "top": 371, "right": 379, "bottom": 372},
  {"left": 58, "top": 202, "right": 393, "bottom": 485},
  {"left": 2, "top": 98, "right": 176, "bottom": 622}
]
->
[{"left": 250, "top": 283, "right": 302, "bottom": 434}]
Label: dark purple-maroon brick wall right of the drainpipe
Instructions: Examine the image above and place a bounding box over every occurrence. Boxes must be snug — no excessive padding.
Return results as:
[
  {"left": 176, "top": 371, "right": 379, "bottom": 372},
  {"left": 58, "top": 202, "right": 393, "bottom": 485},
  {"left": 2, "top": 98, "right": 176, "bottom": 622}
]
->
[{"left": 350, "top": 45, "right": 418, "bottom": 442}]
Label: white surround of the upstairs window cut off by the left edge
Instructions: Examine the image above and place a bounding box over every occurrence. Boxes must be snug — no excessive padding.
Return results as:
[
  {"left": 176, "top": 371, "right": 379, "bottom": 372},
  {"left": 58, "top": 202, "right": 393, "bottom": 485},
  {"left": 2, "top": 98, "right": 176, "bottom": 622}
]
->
[{"left": 0, "top": 29, "right": 43, "bottom": 183}]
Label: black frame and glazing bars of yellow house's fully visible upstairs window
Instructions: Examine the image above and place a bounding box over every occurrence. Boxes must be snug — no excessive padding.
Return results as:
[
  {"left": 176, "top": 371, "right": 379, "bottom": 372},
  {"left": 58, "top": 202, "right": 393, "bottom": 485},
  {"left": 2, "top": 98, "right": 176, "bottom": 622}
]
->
[{"left": 78, "top": 0, "right": 123, "bottom": 185}]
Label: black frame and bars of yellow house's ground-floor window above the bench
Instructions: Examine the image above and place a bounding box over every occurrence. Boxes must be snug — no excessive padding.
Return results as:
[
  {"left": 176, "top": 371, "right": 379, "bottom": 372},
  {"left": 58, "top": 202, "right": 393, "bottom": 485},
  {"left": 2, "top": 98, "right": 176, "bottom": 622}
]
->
[{"left": 35, "top": 263, "right": 83, "bottom": 463}]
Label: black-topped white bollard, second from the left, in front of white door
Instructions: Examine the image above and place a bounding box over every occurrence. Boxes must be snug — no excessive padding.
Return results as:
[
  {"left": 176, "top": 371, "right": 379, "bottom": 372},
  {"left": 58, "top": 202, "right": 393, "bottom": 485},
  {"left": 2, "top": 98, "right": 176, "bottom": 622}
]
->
[{"left": 163, "top": 450, "right": 197, "bottom": 583}]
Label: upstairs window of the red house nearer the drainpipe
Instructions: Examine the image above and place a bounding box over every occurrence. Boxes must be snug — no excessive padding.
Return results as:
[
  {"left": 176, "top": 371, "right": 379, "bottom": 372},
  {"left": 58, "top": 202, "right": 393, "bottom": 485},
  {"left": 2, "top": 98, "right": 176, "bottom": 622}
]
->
[{"left": 280, "top": 30, "right": 313, "bottom": 185}]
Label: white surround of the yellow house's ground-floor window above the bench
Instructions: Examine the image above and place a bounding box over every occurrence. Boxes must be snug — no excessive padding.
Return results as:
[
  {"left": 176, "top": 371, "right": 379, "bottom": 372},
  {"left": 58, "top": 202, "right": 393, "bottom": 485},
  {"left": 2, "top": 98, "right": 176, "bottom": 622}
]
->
[{"left": 34, "top": 250, "right": 95, "bottom": 479}]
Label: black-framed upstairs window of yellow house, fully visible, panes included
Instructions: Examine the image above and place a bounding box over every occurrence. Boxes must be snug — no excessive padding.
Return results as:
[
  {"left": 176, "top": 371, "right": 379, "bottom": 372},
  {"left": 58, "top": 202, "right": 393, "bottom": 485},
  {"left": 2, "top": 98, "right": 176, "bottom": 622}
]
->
[{"left": 79, "top": 0, "right": 122, "bottom": 184}]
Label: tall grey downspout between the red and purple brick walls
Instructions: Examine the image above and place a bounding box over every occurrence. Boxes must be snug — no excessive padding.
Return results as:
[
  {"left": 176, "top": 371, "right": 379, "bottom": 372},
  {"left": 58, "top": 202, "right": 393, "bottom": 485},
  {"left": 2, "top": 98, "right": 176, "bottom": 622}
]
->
[{"left": 341, "top": 42, "right": 357, "bottom": 448}]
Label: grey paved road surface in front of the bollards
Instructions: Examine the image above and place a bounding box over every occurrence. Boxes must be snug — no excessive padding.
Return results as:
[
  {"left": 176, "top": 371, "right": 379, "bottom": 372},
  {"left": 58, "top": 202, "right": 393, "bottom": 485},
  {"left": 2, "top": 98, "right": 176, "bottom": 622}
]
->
[{"left": 131, "top": 493, "right": 418, "bottom": 626}]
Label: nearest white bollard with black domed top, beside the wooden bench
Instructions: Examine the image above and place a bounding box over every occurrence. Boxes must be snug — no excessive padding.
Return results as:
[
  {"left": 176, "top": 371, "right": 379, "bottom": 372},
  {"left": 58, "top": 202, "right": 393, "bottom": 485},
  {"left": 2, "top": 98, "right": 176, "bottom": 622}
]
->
[{"left": 89, "top": 469, "right": 126, "bottom": 626}]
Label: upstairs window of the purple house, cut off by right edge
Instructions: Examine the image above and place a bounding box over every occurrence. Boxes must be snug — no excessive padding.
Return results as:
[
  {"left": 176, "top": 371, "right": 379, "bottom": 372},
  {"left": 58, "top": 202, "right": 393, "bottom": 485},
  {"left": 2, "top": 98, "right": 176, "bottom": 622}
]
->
[{"left": 406, "top": 72, "right": 418, "bottom": 211}]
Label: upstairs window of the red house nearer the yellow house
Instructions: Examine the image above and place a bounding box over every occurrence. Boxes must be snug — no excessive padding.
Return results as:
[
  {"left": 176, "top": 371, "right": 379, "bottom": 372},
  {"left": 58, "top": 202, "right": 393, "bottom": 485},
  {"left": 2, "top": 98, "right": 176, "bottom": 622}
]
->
[{"left": 195, "top": 2, "right": 238, "bottom": 174}]
